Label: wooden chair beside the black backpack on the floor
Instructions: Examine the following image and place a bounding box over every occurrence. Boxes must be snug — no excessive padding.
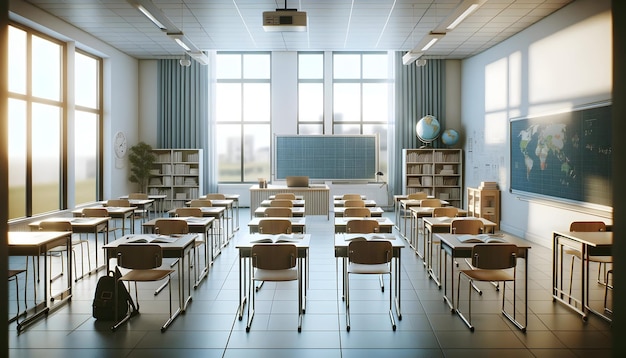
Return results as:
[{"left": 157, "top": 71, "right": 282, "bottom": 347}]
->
[{"left": 111, "top": 245, "right": 174, "bottom": 332}]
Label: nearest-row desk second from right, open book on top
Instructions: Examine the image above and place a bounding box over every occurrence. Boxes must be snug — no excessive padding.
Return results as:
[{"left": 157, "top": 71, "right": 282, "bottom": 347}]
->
[{"left": 435, "top": 234, "right": 531, "bottom": 331}]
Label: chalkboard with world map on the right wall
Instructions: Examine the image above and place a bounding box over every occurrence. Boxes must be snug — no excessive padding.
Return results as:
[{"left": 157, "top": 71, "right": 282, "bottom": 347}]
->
[{"left": 510, "top": 105, "right": 612, "bottom": 206}]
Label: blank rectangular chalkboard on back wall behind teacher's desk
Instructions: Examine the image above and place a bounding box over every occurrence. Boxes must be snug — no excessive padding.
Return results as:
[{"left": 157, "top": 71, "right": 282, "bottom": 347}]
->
[{"left": 274, "top": 135, "right": 378, "bottom": 180}]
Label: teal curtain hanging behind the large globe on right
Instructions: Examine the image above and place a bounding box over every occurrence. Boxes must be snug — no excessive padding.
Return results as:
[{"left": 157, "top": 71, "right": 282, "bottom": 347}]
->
[{"left": 389, "top": 52, "right": 446, "bottom": 194}]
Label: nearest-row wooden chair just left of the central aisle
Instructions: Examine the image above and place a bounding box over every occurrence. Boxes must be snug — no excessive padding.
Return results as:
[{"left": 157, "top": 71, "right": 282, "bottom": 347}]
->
[{"left": 246, "top": 244, "right": 304, "bottom": 332}]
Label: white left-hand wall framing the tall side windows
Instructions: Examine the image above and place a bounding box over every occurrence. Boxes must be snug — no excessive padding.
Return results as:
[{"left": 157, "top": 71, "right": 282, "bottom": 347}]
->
[{"left": 9, "top": 0, "right": 139, "bottom": 201}]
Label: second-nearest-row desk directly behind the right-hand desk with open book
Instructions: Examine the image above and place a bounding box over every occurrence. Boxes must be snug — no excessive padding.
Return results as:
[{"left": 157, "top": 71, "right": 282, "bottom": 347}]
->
[{"left": 422, "top": 216, "right": 498, "bottom": 288}]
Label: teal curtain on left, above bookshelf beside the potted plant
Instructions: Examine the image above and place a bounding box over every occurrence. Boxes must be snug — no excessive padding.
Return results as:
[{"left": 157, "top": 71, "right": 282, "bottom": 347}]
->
[{"left": 157, "top": 59, "right": 217, "bottom": 193}]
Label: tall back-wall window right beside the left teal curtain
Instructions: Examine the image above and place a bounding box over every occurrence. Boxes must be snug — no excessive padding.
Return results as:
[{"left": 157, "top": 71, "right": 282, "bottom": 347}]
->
[{"left": 215, "top": 52, "right": 271, "bottom": 183}]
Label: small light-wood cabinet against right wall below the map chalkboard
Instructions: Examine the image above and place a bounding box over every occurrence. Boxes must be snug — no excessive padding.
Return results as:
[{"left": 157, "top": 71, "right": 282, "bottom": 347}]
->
[{"left": 467, "top": 182, "right": 500, "bottom": 230}]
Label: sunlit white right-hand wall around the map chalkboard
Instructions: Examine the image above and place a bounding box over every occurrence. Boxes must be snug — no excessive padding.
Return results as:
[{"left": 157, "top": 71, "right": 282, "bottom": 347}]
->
[{"left": 462, "top": 0, "right": 612, "bottom": 247}]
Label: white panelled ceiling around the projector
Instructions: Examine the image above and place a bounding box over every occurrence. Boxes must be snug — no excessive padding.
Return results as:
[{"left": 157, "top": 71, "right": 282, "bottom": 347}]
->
[{"left": 26, "top": 0, "right": 573, "bottom": 59}]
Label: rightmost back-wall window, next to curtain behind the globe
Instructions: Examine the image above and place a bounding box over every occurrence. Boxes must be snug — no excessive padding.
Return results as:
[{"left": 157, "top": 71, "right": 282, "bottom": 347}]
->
[{"left": 332, "top": 52, "right": 393, "bottom": 173}]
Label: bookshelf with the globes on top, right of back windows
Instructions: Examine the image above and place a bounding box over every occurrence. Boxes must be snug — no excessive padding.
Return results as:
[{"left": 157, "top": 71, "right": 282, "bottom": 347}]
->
[{"left": 402, "top": 148, "right": 463, "bottom": 208}]
